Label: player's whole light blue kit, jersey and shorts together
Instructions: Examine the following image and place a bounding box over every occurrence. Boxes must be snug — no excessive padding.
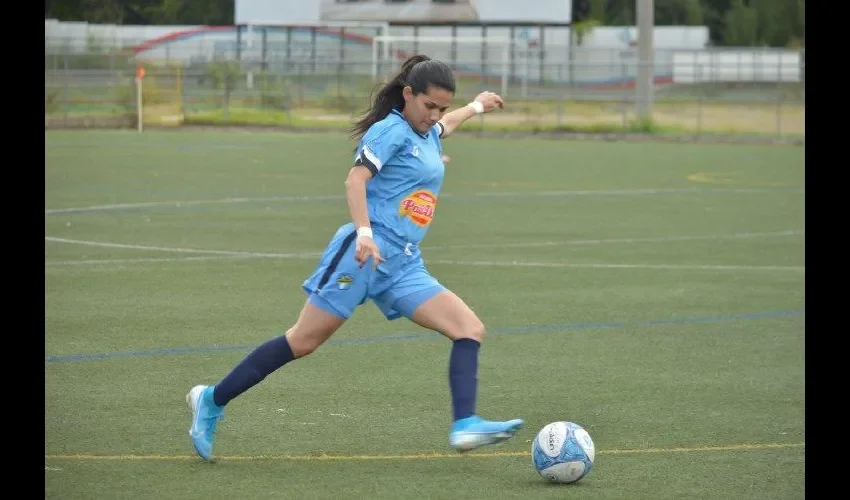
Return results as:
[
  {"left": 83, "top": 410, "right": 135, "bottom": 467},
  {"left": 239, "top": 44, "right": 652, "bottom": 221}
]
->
[{"left": 302, "top": 111, "right": 445, "bottom": 319}]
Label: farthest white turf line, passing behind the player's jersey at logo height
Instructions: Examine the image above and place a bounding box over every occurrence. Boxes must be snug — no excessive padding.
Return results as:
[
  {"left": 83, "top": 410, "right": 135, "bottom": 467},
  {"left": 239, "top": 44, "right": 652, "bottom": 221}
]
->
[{"left": 44, "top": 188, "right": 804, "bottom": 215}]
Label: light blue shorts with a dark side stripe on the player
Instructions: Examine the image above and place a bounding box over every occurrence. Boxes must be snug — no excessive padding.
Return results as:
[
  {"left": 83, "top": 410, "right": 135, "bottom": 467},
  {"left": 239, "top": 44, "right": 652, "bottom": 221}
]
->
[{"left": 302, "top": 223, "right": 446, "bottom": 320}]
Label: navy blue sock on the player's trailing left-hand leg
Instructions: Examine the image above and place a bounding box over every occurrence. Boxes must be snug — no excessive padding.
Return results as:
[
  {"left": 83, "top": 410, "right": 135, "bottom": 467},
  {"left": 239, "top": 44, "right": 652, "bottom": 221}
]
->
[{"left": 213, "top": 335, "right": 295, "bottom": 406}]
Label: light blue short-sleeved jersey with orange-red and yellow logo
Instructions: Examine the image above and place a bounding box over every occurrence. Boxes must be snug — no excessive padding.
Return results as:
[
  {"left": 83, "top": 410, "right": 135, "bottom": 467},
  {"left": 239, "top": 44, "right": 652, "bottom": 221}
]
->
[{"left": 354, "top": 110, "right": 446, "bottom": 244}]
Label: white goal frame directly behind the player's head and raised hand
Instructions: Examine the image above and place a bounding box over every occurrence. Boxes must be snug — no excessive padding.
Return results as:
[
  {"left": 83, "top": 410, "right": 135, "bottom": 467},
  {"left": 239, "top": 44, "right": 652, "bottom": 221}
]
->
[{"left": 372, "top": 35, "right": 510, "bottom": 96}]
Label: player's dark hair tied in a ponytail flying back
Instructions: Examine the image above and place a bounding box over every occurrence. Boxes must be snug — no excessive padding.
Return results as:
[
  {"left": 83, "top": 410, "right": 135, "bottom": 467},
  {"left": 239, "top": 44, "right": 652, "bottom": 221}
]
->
[{"left": 351, "top": 54, "right": 455, "bottom": 139}]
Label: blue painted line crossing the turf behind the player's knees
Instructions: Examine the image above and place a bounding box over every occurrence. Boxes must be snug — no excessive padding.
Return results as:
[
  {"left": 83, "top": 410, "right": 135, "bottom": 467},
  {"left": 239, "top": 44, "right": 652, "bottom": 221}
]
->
[{"left": 45, "top": 309, "right": 805, "bottom": 364}]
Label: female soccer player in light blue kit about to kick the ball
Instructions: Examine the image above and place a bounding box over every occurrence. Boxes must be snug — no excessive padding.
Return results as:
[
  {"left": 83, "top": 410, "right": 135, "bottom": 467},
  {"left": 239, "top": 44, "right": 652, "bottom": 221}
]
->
[{"left": 186, "top": 55, "right": 523, "bottom": 460}]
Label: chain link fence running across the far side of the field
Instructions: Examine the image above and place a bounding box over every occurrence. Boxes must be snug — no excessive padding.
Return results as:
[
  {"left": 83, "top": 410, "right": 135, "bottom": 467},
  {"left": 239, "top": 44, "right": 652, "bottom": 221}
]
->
[{"left": 45, "top": 43, "right": 805, "bottom": 138}]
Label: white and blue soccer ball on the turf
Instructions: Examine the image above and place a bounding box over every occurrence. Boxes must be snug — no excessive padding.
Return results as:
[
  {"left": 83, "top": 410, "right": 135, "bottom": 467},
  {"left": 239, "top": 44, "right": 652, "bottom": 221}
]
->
[{"left": 531, "top": 421, "right": 596, "bottom": 483}]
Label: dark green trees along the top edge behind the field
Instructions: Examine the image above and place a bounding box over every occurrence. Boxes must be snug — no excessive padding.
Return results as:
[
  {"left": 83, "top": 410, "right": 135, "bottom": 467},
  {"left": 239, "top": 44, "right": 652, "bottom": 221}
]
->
[{"left": 44, "top": 0, "right": 806, "bottom": 47}]
